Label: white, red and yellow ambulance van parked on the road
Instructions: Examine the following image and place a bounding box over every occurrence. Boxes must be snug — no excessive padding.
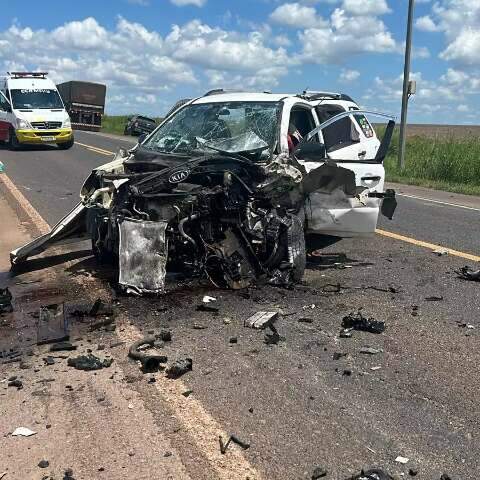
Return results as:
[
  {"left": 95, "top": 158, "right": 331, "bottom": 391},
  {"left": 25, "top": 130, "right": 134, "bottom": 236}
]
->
[{"left": 0, "top": 72, "right": 73, "bottom": 150}]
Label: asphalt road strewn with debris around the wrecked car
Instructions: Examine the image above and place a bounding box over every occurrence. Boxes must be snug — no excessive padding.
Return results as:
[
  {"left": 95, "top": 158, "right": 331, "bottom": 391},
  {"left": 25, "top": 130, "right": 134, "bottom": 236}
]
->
[{"left": 0, "top": 132, "right": 480, "bottom": 480}]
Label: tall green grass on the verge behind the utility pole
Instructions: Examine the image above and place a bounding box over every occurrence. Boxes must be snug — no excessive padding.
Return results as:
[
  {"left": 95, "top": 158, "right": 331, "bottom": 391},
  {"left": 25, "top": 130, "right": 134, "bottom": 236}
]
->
[{"left": 385, "top": 127, "right": 480, "bottom": 195}]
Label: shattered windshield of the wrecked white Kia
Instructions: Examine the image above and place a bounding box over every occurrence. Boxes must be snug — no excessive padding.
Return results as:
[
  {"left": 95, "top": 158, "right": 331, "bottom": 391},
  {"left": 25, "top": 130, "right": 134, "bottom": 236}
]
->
[{"left": 142, "top": 102, "right": 279, "bottom": 154}]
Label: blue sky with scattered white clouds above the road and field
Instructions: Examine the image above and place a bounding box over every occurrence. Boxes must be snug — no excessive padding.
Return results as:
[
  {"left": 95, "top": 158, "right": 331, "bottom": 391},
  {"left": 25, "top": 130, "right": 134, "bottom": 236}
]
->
[{"left": 0, "top": 0, "right": 480, "bottom": 124}]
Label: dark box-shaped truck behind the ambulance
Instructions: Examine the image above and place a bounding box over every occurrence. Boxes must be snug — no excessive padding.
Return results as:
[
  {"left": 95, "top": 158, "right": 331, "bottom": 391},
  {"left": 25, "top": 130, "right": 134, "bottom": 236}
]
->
[{"left": 57, "top": 80, "right": 107, "bottom": 132}]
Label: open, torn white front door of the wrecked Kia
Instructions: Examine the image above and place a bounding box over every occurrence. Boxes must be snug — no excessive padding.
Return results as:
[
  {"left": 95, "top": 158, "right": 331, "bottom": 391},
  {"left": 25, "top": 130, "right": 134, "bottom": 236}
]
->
[{"left": 299, "top": 114, "right": 396, "bottom": 237}]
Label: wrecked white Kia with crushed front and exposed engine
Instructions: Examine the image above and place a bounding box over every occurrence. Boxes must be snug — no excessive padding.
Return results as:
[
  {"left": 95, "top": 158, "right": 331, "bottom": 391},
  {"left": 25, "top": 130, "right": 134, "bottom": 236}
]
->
[{"left": 11, "top": 91, "right": 395, "bottom": 293}]
